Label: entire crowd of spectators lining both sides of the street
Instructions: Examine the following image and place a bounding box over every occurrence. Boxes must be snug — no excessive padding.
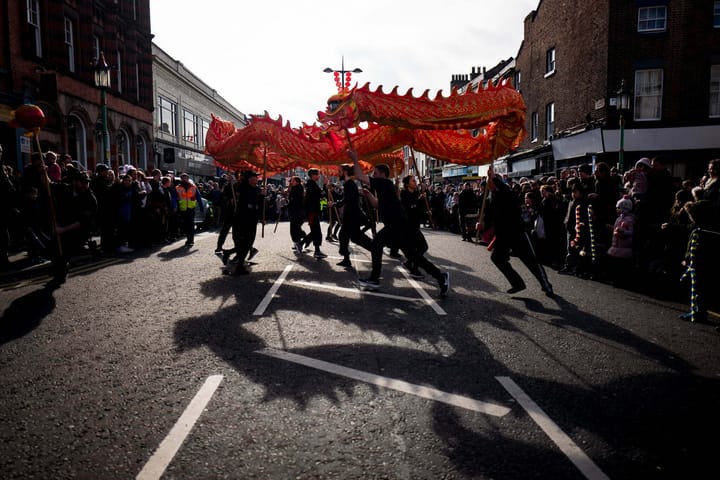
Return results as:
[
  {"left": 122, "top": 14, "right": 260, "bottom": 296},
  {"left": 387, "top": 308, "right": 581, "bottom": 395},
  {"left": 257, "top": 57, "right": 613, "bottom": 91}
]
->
[{"left": 0, "top": 146, "right": 720, "bottom": 316}]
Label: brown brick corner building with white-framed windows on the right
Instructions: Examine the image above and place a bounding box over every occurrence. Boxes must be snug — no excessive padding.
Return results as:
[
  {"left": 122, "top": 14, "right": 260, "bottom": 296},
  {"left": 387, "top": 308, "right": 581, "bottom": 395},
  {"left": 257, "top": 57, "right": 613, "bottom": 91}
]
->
[{"left": 453, "top": 0, "right": 720, "bottom": 178}]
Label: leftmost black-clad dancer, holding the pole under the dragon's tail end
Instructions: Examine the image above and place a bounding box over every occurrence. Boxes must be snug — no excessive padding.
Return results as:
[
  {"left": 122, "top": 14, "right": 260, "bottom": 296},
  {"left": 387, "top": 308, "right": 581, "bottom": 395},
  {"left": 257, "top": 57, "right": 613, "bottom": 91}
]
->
[{"left": 223, "top": 170, "right": 264, "bottom": 275}]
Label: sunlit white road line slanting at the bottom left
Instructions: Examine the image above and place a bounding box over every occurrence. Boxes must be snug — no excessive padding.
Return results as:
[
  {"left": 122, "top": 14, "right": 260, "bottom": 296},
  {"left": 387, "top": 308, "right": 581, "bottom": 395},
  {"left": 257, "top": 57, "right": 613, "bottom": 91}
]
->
[{"left": 135, "top": 375, "right": 223, "bottom": 480}]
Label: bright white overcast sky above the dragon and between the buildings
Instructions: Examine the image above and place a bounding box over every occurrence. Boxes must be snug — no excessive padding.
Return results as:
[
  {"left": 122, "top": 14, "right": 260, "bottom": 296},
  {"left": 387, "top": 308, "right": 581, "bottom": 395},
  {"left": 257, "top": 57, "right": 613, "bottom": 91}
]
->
[{"left": 150, "top": 0, "right": 538, "bottom": 127}]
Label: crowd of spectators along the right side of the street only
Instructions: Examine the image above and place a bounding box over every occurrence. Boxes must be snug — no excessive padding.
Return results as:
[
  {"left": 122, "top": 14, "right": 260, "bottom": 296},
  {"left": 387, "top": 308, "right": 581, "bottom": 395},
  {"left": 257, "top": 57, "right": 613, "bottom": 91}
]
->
[{"left": 427, "top": 157, "right": 720, "bottom": 304}]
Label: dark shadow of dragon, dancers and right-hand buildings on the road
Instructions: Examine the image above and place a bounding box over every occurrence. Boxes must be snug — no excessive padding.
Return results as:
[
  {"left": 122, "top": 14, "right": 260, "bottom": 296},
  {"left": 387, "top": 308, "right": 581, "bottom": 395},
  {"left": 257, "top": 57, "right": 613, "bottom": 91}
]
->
[{"left": 175, "top": 262, "right": 720, "bottom": 479}]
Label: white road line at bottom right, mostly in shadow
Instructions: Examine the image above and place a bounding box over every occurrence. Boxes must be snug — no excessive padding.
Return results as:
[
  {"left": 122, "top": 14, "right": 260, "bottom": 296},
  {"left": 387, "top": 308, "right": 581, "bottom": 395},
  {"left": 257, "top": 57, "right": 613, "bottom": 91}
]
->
[{"left": 495, "top": 377, "right": 610, "bottom": 480}]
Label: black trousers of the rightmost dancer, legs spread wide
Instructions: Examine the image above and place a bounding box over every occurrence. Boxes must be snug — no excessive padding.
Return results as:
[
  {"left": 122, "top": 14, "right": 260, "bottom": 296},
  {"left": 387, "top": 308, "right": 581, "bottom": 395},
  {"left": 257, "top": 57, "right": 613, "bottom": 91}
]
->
[{"left": 490, "top": 232, "right": 552, "bottom": 290}]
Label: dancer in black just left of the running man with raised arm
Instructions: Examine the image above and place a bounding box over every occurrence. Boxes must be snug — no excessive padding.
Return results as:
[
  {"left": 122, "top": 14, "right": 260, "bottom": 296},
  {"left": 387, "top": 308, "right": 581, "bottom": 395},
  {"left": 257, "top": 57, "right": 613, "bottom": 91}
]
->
[{"left": 338, "top": 165, "right": 372, "bottom": 268}]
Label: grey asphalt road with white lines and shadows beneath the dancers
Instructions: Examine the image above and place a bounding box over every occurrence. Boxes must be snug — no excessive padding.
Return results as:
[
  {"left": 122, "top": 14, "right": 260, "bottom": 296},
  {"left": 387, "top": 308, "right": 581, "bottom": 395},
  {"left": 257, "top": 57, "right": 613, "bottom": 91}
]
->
[{"left": 0, "top": 223, "right": 720, "bottom": 479}]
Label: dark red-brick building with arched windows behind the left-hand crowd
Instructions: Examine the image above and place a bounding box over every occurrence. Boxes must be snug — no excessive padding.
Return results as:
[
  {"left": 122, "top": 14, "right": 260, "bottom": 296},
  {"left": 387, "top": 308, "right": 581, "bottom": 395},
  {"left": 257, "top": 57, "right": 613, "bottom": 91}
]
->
[{"left": 0, "top": 0, "right": 153, "bottom": 172}]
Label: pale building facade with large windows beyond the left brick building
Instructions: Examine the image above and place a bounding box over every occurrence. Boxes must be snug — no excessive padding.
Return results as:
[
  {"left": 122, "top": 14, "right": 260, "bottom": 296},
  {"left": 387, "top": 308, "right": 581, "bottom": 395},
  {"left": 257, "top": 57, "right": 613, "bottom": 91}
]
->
[{"left": 152, "top": 44, "right": 247, "bottom": 177}]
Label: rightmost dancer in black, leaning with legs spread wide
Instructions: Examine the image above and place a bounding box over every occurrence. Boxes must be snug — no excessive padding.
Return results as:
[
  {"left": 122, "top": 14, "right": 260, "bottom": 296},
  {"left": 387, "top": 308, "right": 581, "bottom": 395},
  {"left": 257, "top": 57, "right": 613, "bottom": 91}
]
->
[{"left": 488, "top": 167, "right": 554, "bottom": 297}]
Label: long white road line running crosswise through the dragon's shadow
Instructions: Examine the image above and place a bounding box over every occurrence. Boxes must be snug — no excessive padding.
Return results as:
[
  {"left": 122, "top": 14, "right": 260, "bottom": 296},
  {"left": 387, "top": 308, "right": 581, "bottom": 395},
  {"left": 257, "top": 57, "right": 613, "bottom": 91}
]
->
[{"left": 256, "top": 348, "right": 510, "bottom": 417}]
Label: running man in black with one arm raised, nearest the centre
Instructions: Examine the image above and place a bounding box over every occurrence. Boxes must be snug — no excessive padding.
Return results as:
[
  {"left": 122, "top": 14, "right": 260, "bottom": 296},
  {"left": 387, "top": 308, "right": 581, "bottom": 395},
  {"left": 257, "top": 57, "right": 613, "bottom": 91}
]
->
[{"left": 348, "top": 149, "right": 450, "bottom": 296}]
